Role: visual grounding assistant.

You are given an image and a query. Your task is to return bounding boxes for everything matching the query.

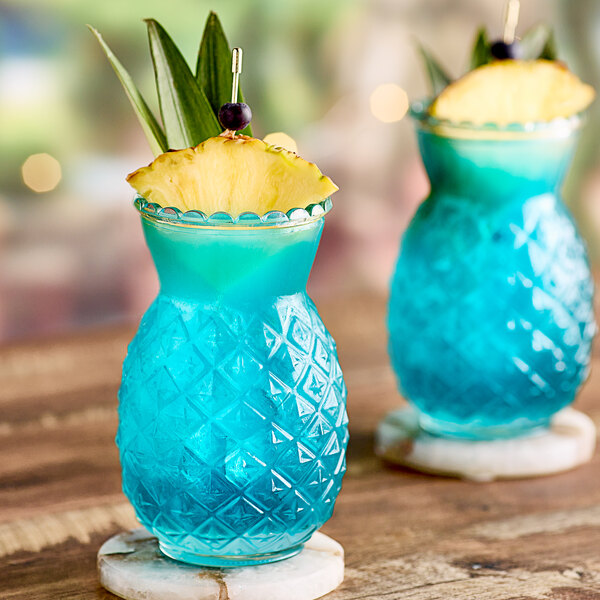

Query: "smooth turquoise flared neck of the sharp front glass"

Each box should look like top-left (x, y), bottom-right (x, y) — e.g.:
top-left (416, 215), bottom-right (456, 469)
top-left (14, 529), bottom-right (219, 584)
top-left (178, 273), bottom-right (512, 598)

top-left (142, 217), bottom-right (324, 304)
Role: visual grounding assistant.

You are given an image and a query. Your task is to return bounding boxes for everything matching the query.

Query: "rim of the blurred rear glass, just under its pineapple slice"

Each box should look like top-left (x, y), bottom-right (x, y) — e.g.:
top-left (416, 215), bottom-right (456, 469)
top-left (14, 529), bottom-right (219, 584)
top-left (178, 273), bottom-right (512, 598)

top-left (408, 98), bottom-right (586, 136)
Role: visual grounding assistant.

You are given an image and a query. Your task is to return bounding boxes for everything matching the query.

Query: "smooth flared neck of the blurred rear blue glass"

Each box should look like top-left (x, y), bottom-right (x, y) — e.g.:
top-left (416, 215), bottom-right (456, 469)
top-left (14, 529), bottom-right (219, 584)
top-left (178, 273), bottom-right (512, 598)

top-left (417, 125), bottom-right (578, 202)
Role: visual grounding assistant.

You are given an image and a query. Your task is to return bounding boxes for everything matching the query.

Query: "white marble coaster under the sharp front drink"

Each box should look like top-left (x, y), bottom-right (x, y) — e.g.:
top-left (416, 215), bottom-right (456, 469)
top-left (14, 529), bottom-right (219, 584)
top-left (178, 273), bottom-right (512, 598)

top-left (98, 528), bottom-right (344, 600)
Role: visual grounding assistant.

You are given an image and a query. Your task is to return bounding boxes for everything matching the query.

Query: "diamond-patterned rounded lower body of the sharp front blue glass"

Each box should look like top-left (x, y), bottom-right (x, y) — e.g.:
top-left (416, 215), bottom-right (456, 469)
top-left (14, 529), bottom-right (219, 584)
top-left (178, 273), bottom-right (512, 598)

top-left (118, 294), bottom-right (348, 556)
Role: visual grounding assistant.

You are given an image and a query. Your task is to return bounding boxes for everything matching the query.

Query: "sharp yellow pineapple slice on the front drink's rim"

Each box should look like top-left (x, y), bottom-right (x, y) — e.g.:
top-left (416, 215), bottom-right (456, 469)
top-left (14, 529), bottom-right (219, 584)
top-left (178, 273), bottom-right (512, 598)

top-left (127, 135), bottom-right (338, 217)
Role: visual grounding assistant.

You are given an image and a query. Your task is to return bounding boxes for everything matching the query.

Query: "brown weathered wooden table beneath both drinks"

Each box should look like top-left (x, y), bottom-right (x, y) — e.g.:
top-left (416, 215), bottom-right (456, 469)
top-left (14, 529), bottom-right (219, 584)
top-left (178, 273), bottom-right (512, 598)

top-left (0, 297), bottom-right (600, 600)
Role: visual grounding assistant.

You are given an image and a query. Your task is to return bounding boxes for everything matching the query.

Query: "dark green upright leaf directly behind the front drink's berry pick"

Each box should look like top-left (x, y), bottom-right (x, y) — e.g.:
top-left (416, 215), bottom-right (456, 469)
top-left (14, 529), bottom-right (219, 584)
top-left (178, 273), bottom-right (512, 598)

top-left (196, 12), bottom-right (252, 136)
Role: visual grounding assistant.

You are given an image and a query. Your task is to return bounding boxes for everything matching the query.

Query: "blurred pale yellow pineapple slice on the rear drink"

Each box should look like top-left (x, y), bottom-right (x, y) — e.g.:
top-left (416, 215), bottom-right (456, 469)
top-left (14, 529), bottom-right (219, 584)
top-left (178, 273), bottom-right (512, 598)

top-left (429, 60), bottom-right (595, 126)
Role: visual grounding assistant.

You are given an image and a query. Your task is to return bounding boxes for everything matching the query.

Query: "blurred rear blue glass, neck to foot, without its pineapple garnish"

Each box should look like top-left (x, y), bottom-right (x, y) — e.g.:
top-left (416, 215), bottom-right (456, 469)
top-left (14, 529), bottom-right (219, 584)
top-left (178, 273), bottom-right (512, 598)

top-left (389, 125), bottom-right (595, 438)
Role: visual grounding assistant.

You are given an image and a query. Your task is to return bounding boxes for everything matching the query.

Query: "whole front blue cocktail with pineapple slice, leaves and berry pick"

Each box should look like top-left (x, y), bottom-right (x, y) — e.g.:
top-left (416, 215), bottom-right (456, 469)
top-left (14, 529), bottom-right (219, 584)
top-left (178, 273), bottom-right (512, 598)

top-left (92, 13), bottom-right (348, 567)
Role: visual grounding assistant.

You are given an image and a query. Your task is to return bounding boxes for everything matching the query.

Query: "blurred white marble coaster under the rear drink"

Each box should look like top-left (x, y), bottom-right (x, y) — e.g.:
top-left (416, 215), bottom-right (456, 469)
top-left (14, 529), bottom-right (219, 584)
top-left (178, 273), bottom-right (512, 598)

top-left (375, 408), bottom-right (596, 481)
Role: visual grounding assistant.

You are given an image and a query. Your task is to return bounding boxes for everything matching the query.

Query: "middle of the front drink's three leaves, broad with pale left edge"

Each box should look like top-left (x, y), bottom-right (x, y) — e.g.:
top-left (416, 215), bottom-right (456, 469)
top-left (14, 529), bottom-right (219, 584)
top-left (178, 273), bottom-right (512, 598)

top-left (146, 19), bottom-right (222, 150)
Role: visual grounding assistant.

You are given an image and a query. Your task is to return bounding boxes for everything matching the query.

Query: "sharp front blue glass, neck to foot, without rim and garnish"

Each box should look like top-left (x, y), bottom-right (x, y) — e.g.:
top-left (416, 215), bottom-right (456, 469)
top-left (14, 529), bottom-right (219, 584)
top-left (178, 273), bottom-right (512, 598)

top-left (117, 217), bottom-right (348, 566)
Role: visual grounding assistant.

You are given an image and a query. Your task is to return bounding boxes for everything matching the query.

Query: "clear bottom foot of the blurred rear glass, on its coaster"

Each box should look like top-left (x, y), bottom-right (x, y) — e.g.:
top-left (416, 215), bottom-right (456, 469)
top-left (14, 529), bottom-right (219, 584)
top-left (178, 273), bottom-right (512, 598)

top-left (418, 413), bottom-right (553, 440)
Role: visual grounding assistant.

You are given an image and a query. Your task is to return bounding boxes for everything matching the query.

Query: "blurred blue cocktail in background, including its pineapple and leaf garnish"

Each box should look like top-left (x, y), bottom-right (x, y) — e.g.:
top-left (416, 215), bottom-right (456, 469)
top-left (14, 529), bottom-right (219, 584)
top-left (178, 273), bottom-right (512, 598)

top-left (388, 29), bottom-right (596, 439)
